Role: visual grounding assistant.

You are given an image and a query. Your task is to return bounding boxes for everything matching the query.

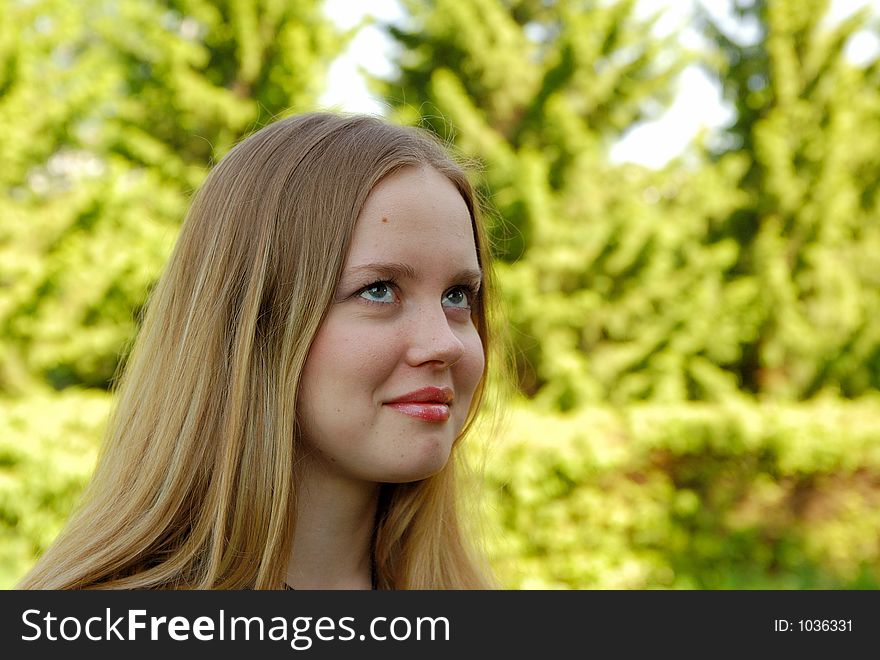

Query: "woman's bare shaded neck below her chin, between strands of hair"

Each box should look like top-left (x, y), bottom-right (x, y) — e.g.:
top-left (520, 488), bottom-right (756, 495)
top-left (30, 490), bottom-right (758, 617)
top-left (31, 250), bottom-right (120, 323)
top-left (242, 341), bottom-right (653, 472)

top-left (286, 460), bottom-right (379, 589)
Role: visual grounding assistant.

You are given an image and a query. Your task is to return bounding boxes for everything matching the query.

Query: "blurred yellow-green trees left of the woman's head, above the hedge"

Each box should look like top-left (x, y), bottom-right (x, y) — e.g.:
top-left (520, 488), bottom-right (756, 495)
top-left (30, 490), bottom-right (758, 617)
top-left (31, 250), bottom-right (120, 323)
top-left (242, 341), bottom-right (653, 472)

top-left (0, 0), bottom-right (346, 392)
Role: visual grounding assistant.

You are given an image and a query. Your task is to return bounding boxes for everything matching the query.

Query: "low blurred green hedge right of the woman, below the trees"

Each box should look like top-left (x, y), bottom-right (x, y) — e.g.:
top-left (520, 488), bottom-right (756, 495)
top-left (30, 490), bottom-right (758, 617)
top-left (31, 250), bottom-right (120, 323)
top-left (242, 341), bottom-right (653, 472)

top-left (486, 399), bottom-right (880, 589)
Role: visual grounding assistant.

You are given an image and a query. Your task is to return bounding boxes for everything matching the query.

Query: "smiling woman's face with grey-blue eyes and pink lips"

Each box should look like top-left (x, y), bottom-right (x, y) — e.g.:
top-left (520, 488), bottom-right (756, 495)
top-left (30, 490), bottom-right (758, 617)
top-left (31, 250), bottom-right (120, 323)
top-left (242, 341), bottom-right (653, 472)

top-left (299, 167), bottom-right (484, 483)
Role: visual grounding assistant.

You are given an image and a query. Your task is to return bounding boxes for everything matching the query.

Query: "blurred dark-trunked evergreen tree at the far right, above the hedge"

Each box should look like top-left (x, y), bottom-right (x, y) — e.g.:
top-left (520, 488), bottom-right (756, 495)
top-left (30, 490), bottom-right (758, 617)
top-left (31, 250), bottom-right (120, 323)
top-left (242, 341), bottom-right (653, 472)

top-left (704, 0), bottom-right (880, 399)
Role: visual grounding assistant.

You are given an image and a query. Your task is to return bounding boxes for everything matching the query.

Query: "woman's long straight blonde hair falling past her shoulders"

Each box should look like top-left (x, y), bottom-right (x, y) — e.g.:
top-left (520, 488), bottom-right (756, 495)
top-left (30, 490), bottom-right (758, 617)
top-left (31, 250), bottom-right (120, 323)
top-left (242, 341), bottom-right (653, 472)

top-left (19, 113), bottom-right (492, 589)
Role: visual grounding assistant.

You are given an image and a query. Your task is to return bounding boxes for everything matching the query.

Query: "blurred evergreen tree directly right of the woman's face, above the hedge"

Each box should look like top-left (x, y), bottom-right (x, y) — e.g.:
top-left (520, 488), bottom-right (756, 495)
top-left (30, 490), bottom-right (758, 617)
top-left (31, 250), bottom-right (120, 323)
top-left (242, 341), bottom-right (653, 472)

top-left (383, 0), bottom-right (764, 410)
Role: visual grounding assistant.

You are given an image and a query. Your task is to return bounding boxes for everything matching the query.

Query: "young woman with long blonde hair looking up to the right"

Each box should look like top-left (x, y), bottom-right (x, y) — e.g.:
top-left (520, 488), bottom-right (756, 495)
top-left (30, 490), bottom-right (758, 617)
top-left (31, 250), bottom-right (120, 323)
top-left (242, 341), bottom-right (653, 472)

top-left (19, 113), bottom-right (502, 589)
